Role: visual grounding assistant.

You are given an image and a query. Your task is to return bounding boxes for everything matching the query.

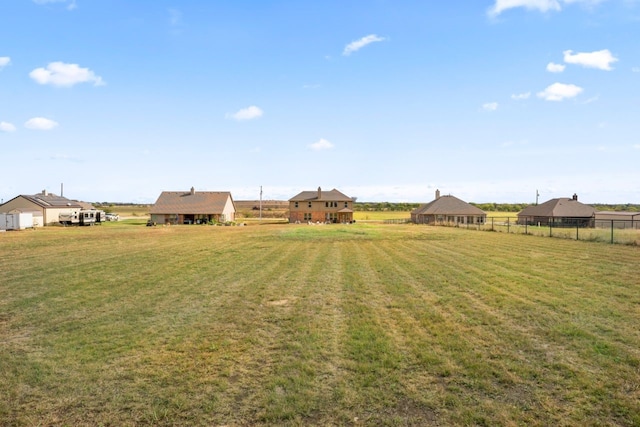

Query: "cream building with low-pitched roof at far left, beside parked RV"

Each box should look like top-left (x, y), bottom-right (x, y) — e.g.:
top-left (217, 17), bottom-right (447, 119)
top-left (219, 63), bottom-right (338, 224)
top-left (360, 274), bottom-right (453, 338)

top-left (0, 190), bottom-right (85, 227)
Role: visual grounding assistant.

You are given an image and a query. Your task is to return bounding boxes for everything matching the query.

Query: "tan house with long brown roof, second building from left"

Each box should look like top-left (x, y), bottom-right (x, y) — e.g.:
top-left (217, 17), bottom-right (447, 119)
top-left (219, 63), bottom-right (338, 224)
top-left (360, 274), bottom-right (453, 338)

top-left (149, 187), bottom-right (236, 225)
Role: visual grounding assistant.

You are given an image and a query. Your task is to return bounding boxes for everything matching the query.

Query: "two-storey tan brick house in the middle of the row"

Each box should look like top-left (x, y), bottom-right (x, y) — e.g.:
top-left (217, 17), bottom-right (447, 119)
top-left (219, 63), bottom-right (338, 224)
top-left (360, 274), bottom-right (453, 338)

top-left (289, 187), bottom-right (353, 223)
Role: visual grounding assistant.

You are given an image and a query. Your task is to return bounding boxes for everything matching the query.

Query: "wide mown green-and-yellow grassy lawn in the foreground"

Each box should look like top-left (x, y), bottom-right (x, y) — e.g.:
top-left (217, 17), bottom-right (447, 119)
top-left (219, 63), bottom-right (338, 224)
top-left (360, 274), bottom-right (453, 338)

top-left (0, 226), bottom-right (640, 426)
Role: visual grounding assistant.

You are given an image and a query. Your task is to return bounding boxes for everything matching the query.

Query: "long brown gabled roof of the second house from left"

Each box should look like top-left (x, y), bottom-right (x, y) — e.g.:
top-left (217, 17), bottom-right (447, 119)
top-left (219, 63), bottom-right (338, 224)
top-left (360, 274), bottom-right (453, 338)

top-left (149, 191), bottom-right (235, 215)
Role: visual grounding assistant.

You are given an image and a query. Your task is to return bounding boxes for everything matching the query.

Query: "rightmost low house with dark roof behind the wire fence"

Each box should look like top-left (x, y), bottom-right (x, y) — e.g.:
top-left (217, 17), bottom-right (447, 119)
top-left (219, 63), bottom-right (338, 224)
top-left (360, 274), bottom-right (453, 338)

top-left (518, 194), bottom-right (596, 227)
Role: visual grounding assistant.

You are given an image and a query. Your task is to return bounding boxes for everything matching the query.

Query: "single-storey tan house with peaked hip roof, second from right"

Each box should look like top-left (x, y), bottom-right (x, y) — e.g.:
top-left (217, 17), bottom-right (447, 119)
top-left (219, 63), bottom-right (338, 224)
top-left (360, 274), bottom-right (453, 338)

top-left (411, 190), bottom-right (487, 225)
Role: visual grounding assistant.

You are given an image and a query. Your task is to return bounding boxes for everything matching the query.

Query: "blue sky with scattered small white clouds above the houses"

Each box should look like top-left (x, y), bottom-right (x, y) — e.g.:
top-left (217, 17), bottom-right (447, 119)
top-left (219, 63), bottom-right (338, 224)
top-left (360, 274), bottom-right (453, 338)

top-left (0, 0), bottom-right (640, 203)
